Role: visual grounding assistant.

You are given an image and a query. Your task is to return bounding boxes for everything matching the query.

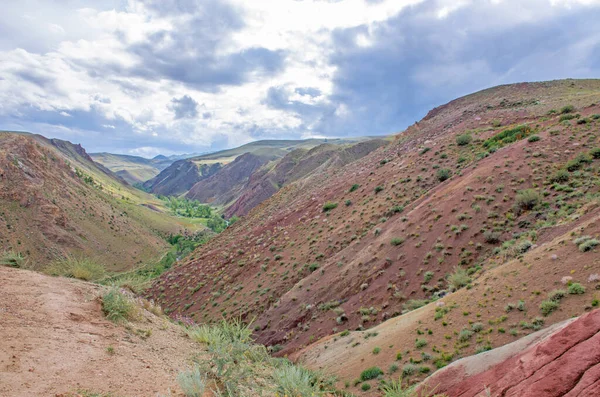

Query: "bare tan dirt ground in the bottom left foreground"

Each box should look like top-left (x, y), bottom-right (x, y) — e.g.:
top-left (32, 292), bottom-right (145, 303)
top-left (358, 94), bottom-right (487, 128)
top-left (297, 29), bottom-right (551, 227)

top-left (0, 267), bottom-right (202, 397)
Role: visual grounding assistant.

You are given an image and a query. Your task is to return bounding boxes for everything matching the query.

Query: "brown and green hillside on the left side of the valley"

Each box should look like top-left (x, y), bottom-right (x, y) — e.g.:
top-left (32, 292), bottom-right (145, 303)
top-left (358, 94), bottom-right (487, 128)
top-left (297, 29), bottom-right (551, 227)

top-left (0, 132), bottom-right (203, 271)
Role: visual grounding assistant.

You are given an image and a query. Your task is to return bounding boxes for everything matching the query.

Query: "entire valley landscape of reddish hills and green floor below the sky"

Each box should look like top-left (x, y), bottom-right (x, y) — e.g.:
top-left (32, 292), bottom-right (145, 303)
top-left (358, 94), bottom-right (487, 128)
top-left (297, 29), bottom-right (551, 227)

top-left (0, 79), bottom-right (600, 397)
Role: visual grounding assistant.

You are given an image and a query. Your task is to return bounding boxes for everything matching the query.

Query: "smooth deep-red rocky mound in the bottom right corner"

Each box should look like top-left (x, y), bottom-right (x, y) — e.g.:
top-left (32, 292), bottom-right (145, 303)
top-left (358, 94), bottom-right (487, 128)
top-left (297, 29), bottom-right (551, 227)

top-left (425, 310), bottom-right (600, 397)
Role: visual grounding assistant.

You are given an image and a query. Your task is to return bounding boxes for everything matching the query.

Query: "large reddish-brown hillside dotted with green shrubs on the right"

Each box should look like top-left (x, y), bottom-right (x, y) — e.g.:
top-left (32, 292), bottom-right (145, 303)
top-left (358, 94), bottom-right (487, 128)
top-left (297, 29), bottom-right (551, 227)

top-left (148, 80), bottom-right (600, 392)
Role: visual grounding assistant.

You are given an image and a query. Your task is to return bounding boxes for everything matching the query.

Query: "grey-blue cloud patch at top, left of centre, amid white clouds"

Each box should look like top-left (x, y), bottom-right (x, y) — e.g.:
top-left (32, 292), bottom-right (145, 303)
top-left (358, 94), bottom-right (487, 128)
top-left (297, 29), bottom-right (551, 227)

top-left (122, 0), bottom-right (285, 92)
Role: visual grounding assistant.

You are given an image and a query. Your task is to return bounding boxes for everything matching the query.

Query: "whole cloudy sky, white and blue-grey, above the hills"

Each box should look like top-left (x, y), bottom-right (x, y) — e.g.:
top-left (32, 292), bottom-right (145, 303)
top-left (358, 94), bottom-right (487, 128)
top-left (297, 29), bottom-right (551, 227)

top-left (0, 0), bottom-right (600, 156)
